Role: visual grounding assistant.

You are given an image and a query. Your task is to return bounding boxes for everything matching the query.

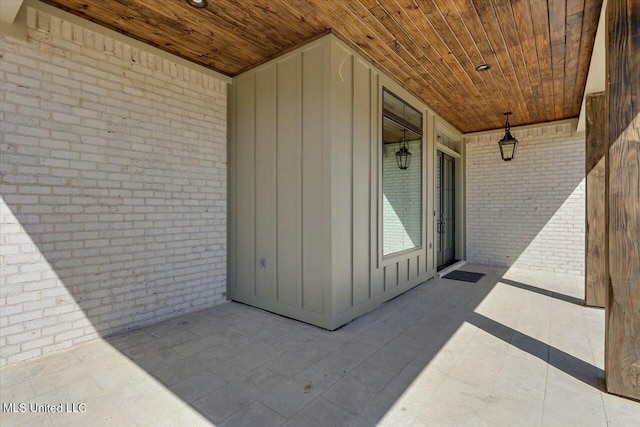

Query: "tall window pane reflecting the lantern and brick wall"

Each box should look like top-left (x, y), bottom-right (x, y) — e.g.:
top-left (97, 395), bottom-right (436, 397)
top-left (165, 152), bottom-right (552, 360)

top-left (382, 91), bottom-right (422, 255)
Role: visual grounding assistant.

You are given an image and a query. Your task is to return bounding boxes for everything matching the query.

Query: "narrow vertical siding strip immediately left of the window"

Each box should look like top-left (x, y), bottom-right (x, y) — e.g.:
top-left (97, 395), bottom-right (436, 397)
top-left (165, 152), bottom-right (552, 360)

top-left (369, 71), bottom-right (385, 298)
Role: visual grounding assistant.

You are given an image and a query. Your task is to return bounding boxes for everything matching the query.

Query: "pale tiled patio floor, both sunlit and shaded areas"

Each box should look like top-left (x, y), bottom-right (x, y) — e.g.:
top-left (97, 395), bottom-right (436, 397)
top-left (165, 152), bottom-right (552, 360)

top-left (0, 266), bottom-right (640, 427)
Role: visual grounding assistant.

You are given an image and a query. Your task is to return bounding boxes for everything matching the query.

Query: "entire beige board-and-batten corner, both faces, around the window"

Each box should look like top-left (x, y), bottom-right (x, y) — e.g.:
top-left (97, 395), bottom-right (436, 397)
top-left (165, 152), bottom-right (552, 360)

top-left (228, 35), bottom-right (435, 329)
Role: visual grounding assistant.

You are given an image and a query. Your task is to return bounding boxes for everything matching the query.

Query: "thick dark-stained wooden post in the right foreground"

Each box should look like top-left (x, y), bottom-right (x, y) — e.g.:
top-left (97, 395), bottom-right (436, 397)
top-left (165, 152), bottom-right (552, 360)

top-left (605, 0), bottom-right (640, 400)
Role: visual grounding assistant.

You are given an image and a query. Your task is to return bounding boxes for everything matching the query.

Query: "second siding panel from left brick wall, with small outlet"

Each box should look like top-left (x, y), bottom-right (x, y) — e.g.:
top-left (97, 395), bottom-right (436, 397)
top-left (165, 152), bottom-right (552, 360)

top-left (255, 65), bottom-right (277, 300)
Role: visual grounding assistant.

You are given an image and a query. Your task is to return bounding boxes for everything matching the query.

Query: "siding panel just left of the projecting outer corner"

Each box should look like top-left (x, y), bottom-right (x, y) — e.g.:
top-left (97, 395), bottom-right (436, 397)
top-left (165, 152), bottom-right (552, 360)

top-left (302, 45), bottom-right (329, 313)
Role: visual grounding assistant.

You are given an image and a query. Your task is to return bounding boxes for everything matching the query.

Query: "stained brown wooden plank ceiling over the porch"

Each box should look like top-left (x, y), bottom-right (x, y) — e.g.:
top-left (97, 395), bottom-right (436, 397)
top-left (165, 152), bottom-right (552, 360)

top-left (46, 0), bottom-right (602, 132)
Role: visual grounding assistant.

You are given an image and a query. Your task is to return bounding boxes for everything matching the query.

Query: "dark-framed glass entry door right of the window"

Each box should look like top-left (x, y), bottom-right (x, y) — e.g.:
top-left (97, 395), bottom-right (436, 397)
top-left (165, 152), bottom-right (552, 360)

top-left (436, 151), bottom-right (456, 268)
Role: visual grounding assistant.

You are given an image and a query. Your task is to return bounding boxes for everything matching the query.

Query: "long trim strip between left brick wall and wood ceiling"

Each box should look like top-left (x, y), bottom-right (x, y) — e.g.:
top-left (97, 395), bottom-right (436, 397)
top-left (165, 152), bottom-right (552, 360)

top-left (28, 0), bottom-right (231, 84)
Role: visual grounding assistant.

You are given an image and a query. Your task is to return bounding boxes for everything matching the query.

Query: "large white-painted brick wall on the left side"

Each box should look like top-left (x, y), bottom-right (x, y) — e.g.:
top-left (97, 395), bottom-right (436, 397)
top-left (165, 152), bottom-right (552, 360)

top-left (0, 9), bottom-right (226, 365)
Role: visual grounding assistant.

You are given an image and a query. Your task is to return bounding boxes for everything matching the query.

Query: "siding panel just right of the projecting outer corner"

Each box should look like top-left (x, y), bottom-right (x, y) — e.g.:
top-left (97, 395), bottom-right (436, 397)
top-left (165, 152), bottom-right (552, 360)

top-left (331, 45), bottom-right (354, 313)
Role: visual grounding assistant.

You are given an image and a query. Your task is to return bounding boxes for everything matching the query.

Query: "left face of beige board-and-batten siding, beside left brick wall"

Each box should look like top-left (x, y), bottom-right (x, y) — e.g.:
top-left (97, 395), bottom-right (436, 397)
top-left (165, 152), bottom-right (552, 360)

top-left (228, 39), bottom-right (330, 327)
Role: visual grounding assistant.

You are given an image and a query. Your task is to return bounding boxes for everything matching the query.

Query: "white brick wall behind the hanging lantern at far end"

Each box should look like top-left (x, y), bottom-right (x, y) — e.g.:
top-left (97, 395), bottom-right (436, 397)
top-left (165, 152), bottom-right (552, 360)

top-left (465, 123), bottom-right (585, 275)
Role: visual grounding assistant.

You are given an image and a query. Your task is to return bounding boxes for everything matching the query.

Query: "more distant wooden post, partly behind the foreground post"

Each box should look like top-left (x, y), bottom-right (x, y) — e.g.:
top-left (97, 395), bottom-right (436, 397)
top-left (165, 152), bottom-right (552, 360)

top-left (584, 92), bottom-right (609, 307)
